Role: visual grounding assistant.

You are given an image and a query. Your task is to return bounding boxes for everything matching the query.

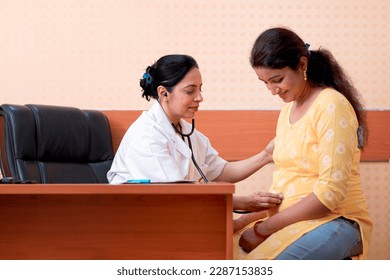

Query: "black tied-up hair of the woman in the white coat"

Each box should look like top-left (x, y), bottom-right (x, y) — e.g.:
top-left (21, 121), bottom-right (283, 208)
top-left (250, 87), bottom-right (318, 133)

top-left (139, 54), bottom-right (199, 101)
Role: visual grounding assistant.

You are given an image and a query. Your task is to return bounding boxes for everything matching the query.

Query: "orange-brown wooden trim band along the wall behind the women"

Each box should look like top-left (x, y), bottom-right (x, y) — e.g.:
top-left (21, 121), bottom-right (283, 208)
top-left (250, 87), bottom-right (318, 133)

top-left (104, 110), bottom-right (390, 162)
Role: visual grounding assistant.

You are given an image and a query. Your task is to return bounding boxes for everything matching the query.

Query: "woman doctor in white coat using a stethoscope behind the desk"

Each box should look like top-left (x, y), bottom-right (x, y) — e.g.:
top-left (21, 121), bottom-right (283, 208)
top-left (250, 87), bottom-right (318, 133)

top-left (107, 55), bottom-right (281, 211)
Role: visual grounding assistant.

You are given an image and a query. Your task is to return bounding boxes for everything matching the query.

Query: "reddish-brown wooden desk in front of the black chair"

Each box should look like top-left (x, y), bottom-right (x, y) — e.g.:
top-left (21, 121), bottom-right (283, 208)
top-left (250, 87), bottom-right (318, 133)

top-left (0, 183), bottom-right (234, 260)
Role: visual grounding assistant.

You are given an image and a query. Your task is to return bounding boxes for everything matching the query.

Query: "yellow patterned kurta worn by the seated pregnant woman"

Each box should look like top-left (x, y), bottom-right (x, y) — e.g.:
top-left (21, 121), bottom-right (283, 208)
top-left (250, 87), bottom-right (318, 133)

top-left (234, 88), bottom-right (372, 259)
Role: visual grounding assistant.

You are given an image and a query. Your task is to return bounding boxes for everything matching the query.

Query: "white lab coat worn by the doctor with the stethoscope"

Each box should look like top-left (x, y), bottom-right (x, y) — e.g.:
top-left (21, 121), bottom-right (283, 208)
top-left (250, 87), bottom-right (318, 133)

top-left (107, 101), bottom-right (227, 184)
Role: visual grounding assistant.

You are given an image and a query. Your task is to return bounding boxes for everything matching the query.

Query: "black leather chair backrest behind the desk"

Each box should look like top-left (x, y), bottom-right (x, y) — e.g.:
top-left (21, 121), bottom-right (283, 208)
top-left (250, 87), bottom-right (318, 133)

top-left (0, 104), bottom-right (114, 183)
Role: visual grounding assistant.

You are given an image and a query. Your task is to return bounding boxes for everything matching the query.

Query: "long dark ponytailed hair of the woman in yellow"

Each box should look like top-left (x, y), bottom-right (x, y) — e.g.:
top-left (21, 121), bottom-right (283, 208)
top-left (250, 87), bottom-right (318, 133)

top-left (250, 27), bottom-right (368, 149)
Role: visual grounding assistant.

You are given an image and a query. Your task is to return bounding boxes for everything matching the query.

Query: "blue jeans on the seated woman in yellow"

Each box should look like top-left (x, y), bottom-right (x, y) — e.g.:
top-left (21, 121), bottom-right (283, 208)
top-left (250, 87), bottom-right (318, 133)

top-left (275, 217), bottom-right (363, 260)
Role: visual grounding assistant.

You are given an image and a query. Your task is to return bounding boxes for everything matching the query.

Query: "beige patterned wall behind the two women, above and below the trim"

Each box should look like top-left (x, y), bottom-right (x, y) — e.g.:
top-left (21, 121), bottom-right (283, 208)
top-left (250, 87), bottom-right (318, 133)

top-left (0, 0), bottom-right (390, 259)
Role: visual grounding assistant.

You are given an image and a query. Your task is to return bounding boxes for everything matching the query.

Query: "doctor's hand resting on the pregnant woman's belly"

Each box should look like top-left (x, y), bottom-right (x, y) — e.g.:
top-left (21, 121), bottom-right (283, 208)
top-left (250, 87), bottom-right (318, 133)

top-left (233, 192), bottom-right (283, 212)
